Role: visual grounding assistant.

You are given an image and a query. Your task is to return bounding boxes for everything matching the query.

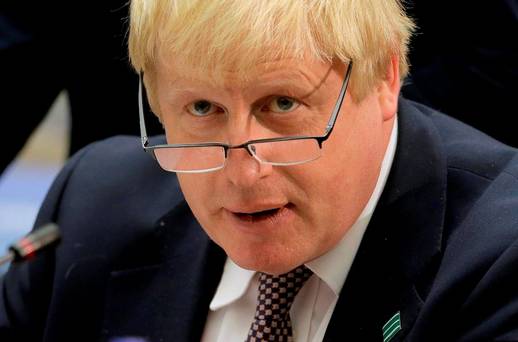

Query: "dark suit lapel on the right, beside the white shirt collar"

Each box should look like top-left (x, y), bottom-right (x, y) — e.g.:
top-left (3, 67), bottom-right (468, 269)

top-left (325, 100), bottom-right (446, 341)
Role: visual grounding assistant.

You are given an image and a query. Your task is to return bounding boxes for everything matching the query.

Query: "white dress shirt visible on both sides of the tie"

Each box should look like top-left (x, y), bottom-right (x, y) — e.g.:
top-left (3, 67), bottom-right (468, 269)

top-left (202, 116), bottom-right (397, 342)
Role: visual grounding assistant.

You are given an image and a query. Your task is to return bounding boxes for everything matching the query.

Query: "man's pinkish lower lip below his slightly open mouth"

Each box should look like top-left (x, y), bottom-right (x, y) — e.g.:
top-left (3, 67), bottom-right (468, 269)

top-left (227, 205), bottom-right (295, 233)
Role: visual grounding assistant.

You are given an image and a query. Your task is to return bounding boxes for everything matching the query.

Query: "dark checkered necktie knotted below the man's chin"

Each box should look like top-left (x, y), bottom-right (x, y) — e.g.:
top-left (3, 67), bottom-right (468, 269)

top-left (246, 265), bottom-right (312, 342)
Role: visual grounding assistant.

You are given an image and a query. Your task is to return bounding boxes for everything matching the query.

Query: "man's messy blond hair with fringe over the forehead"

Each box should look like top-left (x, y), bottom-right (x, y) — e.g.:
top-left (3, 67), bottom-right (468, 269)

top-left (129, 0), bottom-right (414, 100)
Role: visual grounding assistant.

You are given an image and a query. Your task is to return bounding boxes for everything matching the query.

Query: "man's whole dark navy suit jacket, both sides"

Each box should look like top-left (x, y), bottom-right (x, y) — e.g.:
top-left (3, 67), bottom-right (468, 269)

top-left (0, 99), bottom-right (518, 342)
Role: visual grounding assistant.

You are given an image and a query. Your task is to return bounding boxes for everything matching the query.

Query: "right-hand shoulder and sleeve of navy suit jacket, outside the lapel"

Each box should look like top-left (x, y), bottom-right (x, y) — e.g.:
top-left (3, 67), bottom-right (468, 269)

top-left (402, 101), bottom-right (518, 340)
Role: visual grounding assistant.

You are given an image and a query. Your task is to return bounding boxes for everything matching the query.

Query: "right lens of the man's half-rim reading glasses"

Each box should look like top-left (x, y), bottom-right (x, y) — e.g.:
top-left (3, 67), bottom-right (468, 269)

top-left (250, 138), bottom-right (322, 165)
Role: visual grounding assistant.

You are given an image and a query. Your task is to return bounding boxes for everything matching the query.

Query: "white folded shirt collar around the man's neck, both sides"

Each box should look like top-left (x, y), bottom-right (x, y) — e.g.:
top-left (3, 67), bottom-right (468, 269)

top-left (210, 115), bottom-right (398, 311)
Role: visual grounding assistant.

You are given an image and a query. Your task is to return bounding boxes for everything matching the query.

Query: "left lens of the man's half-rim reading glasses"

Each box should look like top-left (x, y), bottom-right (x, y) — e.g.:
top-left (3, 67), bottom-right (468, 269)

top-left (153, 146), bottom-right (225, 172)
